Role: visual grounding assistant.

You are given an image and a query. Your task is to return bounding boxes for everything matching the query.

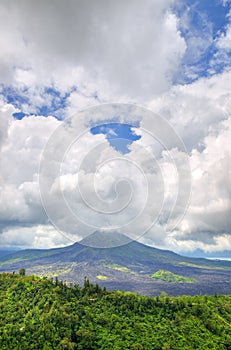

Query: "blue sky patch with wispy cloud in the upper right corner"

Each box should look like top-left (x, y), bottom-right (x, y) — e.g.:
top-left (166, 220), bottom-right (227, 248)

top-left (175, 0), bottom-right (230, 83)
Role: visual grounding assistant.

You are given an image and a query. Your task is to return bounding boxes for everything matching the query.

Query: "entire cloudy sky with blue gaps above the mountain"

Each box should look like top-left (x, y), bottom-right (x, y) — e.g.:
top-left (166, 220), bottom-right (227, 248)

top-left (0, 0), bottom-right (231, 257)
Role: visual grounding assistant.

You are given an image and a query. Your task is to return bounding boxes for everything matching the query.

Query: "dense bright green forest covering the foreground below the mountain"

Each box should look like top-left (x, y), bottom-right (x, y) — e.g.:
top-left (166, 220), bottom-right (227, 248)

top-left (0, 271), bottom-right (231, 350)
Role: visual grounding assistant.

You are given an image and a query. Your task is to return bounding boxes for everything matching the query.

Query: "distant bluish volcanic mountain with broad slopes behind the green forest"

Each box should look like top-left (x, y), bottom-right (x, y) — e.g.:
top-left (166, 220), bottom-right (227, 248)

top-left (0, 232), bottom-right (231, 295)
